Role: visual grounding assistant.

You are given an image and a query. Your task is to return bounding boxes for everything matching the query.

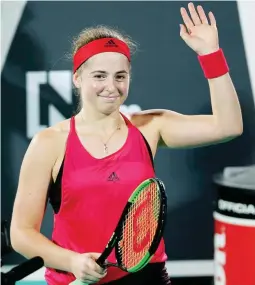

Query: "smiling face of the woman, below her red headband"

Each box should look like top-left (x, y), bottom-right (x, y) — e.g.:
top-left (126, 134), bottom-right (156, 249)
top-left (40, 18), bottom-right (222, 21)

top-left (73, 52), bottom-right (130, 115)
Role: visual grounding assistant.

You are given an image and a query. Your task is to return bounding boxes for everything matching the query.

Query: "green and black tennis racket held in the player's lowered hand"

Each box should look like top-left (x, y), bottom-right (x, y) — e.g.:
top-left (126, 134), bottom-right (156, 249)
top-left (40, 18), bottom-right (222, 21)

top-left (70, 178), bottom-right (167, 285)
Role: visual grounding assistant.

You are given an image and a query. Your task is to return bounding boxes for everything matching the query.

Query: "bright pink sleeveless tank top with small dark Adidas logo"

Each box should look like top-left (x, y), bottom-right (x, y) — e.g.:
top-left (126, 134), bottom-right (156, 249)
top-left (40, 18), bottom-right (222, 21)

top-left (45, 116), bottom-right (167, 285)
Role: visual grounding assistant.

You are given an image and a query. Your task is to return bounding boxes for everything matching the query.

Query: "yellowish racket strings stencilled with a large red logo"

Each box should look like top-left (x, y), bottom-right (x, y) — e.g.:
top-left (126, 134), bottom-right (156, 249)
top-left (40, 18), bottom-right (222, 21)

top-left (119, 183), bottom-right (160, 268)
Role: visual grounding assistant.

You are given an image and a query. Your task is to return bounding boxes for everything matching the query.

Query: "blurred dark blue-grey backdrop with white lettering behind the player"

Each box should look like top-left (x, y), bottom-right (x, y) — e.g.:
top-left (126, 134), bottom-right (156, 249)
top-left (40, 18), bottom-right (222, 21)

top-left (1, 1), bottom-right (255, 285)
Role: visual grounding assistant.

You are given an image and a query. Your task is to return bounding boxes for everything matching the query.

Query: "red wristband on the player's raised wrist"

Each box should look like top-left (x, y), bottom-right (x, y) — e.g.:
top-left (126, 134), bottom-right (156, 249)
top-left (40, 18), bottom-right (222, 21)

top-left (198, 49), bottom-right (229, 79)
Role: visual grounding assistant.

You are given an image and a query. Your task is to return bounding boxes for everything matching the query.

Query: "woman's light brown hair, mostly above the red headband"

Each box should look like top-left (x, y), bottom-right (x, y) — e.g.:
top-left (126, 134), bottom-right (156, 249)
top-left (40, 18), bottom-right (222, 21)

top-left (72, 25), bottom-right (137, 110)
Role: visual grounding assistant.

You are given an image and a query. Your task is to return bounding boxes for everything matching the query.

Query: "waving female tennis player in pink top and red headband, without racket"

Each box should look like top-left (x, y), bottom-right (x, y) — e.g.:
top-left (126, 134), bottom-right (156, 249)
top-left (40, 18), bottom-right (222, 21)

top-left (11, 3), bottom-right (243, 285)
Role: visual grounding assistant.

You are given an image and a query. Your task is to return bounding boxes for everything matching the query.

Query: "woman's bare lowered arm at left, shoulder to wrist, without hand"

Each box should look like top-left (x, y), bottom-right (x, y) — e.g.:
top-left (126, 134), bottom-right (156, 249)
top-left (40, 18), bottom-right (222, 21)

top-left (11, 129), bottom-right (75, 271)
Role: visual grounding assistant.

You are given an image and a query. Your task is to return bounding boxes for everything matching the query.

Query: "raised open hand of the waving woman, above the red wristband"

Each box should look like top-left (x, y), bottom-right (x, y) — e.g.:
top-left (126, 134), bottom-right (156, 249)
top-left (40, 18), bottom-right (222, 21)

top-left (180, 3), bottom-right (219, 55)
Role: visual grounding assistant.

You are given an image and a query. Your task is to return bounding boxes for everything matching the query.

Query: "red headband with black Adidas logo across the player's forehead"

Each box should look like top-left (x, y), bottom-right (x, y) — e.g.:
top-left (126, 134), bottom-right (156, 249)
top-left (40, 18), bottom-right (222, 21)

top-left (73, 38), bottom-right (130, 73)
